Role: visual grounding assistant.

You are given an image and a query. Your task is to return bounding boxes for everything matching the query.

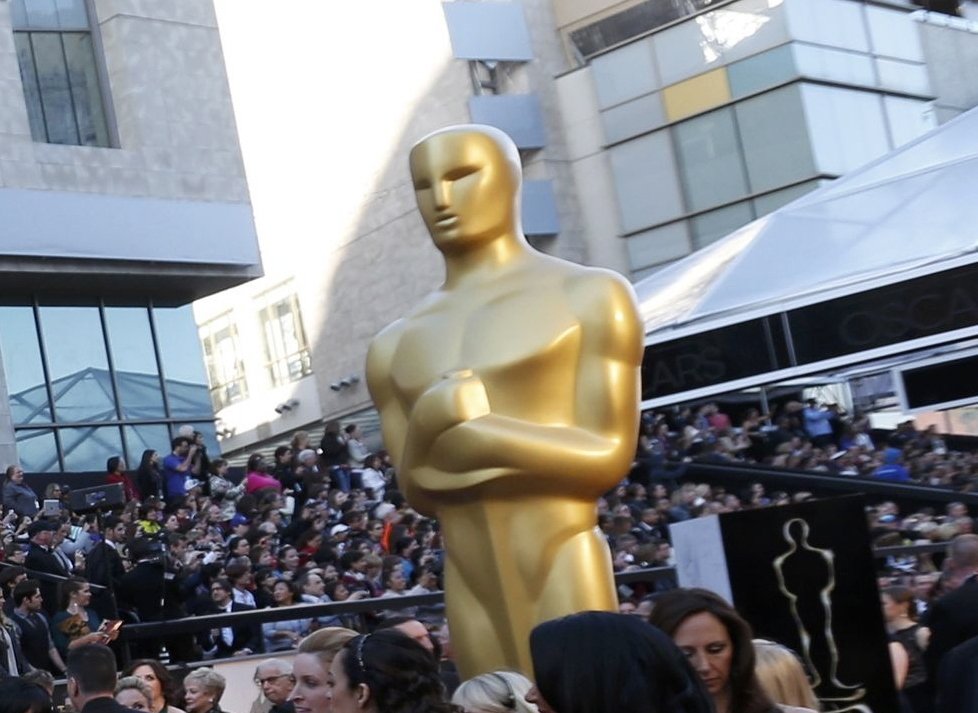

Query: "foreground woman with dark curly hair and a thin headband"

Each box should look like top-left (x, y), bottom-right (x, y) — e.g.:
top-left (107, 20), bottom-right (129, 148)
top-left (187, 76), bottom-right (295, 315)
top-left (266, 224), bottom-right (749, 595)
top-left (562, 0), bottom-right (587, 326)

top-left (327, 629), bottom-right (455, 713)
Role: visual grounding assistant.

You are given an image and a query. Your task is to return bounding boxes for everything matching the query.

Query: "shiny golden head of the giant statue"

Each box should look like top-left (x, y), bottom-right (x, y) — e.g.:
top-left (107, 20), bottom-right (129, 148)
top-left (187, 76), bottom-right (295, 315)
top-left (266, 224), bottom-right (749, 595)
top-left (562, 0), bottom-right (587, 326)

top-left (410, 131), bottom-right (519, 251)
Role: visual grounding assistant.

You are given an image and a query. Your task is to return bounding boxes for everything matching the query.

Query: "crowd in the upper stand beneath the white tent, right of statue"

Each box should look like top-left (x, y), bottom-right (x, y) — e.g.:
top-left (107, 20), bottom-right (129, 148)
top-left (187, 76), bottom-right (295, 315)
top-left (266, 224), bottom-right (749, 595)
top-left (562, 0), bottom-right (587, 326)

top-left (638, 399), bottom-right (978, 491)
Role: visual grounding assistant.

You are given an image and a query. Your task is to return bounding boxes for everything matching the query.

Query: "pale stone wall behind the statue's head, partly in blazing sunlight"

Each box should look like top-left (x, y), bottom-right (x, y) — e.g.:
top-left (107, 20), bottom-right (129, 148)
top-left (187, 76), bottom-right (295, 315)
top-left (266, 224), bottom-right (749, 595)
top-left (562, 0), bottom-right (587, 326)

top-left (195, 0), bottom-right (587, 452)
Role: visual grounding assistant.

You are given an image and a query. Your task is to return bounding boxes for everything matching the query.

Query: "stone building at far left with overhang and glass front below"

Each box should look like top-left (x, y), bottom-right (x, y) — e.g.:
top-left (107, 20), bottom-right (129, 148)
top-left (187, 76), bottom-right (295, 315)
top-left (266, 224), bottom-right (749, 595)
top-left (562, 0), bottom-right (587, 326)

top-left (0, 0), bottom-right (261, 472)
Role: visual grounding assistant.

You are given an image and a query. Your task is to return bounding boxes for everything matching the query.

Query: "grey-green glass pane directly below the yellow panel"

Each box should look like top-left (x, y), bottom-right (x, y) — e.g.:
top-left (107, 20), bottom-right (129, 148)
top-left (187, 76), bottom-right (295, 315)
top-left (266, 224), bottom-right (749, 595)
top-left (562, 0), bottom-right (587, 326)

top-left (675, 109), bottom-right (747, 211)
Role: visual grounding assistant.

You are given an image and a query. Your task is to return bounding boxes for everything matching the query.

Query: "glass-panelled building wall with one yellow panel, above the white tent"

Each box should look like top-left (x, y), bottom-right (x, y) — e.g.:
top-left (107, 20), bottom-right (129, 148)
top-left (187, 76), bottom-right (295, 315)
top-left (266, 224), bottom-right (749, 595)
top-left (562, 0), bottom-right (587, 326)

top-left (557, 0), bottom-right (937, 279)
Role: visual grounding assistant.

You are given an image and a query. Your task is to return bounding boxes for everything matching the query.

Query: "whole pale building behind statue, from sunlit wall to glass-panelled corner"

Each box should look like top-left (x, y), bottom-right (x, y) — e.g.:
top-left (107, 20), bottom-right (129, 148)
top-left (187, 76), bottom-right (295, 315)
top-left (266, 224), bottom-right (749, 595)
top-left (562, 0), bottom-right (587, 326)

top-left (195, 0), bottom-right (978, 457)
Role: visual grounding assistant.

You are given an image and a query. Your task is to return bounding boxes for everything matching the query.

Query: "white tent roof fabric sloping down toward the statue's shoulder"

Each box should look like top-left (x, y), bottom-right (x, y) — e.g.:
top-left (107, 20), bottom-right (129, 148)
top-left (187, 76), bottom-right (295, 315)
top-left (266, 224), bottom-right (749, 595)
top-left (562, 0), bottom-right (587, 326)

top-left (635, 109), bottom-right (978, 341)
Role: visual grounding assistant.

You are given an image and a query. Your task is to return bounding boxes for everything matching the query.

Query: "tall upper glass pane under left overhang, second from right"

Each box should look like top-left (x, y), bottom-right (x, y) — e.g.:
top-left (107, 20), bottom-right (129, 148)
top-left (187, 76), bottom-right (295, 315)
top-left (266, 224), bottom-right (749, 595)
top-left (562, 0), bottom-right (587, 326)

top-left (105, 307), bottom-right (166, 419)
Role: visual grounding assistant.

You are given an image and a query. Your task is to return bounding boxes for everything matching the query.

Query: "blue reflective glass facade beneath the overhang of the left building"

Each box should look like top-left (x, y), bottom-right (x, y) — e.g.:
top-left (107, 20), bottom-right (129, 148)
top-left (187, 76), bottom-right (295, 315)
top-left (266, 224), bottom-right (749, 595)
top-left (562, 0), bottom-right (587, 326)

top-left (0, 300), bottom-right (219, 472)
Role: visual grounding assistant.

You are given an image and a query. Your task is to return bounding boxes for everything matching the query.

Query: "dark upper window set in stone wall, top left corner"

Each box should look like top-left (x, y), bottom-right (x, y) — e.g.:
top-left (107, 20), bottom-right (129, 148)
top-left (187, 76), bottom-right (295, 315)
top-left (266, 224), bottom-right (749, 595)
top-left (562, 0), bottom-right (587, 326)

top-left (10, 0), bottom-right (110, 146)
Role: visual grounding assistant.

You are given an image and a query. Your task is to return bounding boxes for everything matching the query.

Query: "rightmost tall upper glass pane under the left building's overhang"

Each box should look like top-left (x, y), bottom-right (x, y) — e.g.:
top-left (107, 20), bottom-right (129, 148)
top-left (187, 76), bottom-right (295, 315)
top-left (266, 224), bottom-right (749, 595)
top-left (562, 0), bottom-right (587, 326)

top-left (153, 305), bottom-right (214, 419)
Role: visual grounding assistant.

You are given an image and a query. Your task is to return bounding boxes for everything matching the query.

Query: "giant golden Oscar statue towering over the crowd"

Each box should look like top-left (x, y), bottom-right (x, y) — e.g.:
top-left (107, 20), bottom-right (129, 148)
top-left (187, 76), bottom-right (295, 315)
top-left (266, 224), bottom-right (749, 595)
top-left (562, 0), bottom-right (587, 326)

top-left (367, 126), bottom-right (642, 677)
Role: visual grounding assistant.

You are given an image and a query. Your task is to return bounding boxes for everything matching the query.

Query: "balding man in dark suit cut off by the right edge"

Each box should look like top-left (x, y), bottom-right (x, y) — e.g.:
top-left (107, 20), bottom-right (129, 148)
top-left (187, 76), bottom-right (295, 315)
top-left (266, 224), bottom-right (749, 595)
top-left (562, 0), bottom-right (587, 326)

top-left (922, 535), bottom-right (978, 681)
